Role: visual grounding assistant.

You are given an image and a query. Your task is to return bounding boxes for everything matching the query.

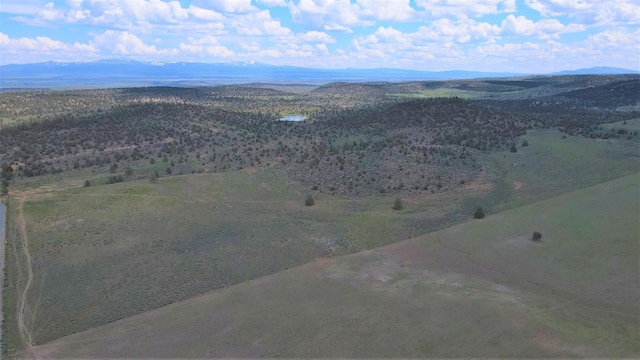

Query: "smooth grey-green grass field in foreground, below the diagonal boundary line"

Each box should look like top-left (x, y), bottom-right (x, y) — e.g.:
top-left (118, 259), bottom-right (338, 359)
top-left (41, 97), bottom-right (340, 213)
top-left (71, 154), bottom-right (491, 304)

top-left (35, 174), bottom-right (640, 358)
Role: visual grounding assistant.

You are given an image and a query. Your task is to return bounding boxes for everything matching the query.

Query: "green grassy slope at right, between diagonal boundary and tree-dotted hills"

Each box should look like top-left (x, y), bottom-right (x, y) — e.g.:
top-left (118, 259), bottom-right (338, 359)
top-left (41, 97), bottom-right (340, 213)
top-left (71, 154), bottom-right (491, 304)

top-left (487, 128), bottom-right (640, 207)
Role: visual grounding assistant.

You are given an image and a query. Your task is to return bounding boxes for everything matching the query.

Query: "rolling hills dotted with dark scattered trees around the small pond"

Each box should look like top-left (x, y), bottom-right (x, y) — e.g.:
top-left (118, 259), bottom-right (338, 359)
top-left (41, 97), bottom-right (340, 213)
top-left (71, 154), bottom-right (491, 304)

top-left (0, 75), bottom-right (640, 196)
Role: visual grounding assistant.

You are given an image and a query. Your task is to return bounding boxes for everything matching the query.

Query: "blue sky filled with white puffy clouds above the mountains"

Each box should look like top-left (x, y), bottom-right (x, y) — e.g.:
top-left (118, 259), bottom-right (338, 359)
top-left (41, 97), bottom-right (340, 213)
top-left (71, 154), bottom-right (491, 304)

top-left (0, 0), bottom-right (640, 73)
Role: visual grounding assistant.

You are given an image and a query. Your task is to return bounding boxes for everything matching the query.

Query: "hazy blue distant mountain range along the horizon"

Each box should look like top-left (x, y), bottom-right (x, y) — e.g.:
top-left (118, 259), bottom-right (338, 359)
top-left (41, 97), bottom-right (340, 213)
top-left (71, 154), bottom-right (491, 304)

top-left (0, 59), bottom-right (640, 89)
